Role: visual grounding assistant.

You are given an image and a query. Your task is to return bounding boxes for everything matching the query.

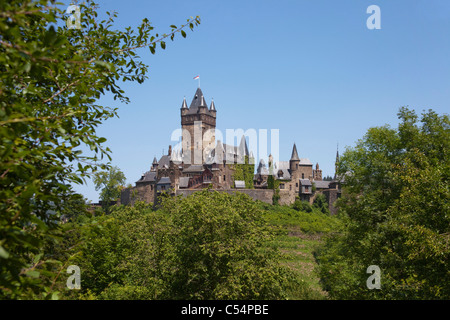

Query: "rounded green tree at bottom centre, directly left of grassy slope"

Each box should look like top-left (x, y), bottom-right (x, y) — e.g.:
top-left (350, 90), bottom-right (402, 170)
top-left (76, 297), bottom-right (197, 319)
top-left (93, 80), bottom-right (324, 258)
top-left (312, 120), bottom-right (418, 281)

top-left (162, 190), bottom-right (288, 299)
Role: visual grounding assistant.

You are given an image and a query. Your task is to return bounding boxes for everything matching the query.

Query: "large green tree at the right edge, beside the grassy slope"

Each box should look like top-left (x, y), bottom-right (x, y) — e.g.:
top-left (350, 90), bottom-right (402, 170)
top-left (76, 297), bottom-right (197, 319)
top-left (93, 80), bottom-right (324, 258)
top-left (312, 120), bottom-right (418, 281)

top-left (319, 107), bottom-right (450, 299)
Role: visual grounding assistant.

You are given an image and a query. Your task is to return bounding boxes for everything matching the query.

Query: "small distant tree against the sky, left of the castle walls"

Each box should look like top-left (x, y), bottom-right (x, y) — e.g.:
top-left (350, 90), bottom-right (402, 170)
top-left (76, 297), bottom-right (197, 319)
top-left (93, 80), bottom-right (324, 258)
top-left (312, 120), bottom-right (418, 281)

top-left (93, 167), bottom-right (126, 214)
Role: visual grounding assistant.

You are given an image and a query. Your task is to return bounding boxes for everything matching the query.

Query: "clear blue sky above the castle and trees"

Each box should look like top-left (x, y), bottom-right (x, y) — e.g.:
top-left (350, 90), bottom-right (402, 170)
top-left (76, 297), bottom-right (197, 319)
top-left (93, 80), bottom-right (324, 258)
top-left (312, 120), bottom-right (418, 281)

top-left (68, 0), bottom-right (450, 202)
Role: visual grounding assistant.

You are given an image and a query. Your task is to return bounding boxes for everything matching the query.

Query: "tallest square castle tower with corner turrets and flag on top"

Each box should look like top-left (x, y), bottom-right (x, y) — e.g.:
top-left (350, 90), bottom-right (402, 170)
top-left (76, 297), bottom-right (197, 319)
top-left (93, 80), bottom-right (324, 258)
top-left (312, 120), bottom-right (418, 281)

top-left (181, 88), bottom-right (217, 165)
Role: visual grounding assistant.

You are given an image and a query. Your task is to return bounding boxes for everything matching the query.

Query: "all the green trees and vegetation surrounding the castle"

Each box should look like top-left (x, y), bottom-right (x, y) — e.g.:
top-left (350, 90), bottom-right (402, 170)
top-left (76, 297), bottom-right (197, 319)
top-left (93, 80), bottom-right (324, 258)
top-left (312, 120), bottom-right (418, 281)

top-left (0, 0), bottom-right (450, 299)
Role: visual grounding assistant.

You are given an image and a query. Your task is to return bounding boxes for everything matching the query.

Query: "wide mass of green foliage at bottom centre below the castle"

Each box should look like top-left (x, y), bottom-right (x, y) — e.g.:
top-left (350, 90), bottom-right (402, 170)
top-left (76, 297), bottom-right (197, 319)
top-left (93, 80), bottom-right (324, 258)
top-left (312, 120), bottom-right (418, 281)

top-left (61, 190), bottom-right (290, 299)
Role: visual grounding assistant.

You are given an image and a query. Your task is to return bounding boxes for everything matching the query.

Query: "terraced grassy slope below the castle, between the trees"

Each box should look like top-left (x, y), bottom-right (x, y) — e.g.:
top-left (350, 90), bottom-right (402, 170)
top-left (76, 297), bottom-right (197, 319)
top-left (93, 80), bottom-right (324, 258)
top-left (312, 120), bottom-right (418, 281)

top-left (262, 204), bottom-right (339, 300)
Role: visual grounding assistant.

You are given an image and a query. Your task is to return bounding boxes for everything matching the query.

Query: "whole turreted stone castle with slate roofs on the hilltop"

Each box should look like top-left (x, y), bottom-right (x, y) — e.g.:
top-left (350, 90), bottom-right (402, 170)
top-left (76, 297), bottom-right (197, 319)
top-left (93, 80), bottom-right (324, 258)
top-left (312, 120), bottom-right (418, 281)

top-left (120, 88), bottom-right (341, 214)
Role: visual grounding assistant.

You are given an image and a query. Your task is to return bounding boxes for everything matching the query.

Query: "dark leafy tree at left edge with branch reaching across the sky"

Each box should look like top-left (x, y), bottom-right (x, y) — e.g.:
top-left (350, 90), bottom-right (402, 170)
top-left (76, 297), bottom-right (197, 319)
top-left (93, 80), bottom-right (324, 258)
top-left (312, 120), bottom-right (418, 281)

top-left (0, 0), bottom-right (199, 298)
